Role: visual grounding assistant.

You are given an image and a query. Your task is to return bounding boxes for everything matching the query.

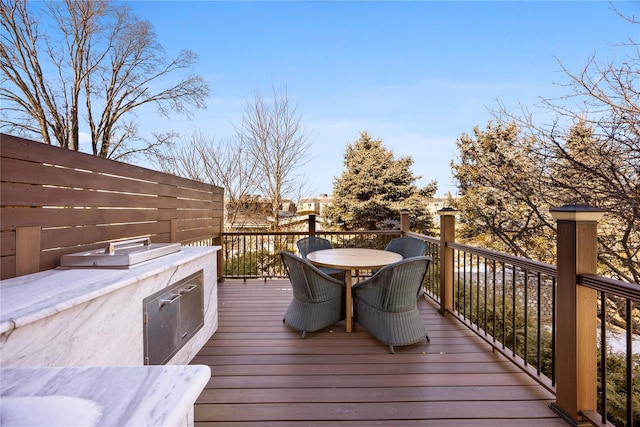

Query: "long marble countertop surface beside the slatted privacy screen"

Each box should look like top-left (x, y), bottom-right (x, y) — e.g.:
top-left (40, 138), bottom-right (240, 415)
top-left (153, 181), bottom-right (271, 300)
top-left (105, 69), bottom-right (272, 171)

top-left (0, 246), bottom-right (220, 334)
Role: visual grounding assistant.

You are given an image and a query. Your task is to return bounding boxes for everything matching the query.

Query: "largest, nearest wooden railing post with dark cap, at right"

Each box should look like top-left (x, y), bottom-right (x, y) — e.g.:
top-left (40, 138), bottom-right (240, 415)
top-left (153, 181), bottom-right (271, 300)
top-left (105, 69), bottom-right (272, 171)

top-left (550, 205), bottom-right (604, 426)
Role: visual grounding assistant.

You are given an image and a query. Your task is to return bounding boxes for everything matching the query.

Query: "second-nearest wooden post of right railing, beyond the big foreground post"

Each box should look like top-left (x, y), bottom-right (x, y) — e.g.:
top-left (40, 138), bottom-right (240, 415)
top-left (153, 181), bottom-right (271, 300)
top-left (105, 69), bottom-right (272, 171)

top-left (438, 208), bottom-right (458, 316)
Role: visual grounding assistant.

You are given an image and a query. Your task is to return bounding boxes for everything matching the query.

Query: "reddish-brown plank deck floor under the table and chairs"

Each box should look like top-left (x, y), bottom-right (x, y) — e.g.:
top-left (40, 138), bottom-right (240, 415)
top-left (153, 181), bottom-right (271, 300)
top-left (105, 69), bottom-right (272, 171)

top-left (192, 280), bottom-right (567, 427)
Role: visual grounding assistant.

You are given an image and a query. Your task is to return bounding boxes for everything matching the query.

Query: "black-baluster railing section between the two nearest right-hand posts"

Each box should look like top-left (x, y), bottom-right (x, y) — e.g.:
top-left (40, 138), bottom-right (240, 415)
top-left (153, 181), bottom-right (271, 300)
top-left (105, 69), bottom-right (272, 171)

top-left (446, 242), bottom-right (556, 391)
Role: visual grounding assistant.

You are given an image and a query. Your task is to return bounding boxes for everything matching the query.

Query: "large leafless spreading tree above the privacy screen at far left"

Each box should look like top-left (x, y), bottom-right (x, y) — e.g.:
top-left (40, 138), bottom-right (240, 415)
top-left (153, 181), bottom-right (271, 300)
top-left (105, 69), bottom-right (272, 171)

top-left (0, 0), bottom-right (209, 159)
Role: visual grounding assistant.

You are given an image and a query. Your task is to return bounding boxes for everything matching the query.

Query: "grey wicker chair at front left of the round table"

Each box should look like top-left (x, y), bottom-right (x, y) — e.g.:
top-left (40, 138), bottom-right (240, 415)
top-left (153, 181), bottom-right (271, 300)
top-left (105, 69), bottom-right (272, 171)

top-left (280, 251), bottom-right (345, 338)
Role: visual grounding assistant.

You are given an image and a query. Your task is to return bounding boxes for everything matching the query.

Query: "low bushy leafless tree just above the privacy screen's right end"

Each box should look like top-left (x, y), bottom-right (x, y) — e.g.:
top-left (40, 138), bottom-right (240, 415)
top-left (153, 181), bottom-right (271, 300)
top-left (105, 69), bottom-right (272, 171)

top-left (150, 130), bottom-right (257, 224)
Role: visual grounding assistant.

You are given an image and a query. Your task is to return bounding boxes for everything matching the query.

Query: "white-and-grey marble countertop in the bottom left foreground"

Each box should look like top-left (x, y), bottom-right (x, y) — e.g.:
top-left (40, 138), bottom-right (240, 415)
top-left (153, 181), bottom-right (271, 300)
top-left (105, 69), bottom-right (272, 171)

top-left (0, 365), bottom-right (211, 427)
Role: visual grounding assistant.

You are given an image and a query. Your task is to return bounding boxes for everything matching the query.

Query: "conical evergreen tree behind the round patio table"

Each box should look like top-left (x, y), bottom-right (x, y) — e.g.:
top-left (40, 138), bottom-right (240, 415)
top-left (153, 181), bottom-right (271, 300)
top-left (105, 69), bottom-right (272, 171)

top-left (324, 132), bottom-right (437, 233)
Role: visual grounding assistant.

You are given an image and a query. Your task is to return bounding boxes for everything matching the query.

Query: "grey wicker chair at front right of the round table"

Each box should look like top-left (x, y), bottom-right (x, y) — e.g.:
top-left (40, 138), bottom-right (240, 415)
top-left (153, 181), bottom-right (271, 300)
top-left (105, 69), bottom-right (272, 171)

top-left (352, 256), bottom-right (431, 353)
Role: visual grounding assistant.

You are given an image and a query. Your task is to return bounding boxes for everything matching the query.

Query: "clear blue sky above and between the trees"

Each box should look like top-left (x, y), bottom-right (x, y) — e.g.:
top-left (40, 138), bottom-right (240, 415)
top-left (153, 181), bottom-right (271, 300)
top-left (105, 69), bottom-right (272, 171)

top-left (124, 1), bottom-right (640, 195)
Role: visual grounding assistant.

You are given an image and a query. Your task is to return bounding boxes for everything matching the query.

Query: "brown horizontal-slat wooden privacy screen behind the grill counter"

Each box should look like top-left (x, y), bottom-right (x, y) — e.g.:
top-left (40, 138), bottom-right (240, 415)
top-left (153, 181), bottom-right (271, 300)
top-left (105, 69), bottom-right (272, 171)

top-left (0, 134), bottom-right (224, 279)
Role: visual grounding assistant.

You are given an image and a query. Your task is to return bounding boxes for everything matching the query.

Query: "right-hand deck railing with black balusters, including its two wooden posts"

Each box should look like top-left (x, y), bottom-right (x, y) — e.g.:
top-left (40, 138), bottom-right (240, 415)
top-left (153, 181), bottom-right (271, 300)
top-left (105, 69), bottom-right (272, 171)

top-left (426, 206), bottom-right (640, 426)
